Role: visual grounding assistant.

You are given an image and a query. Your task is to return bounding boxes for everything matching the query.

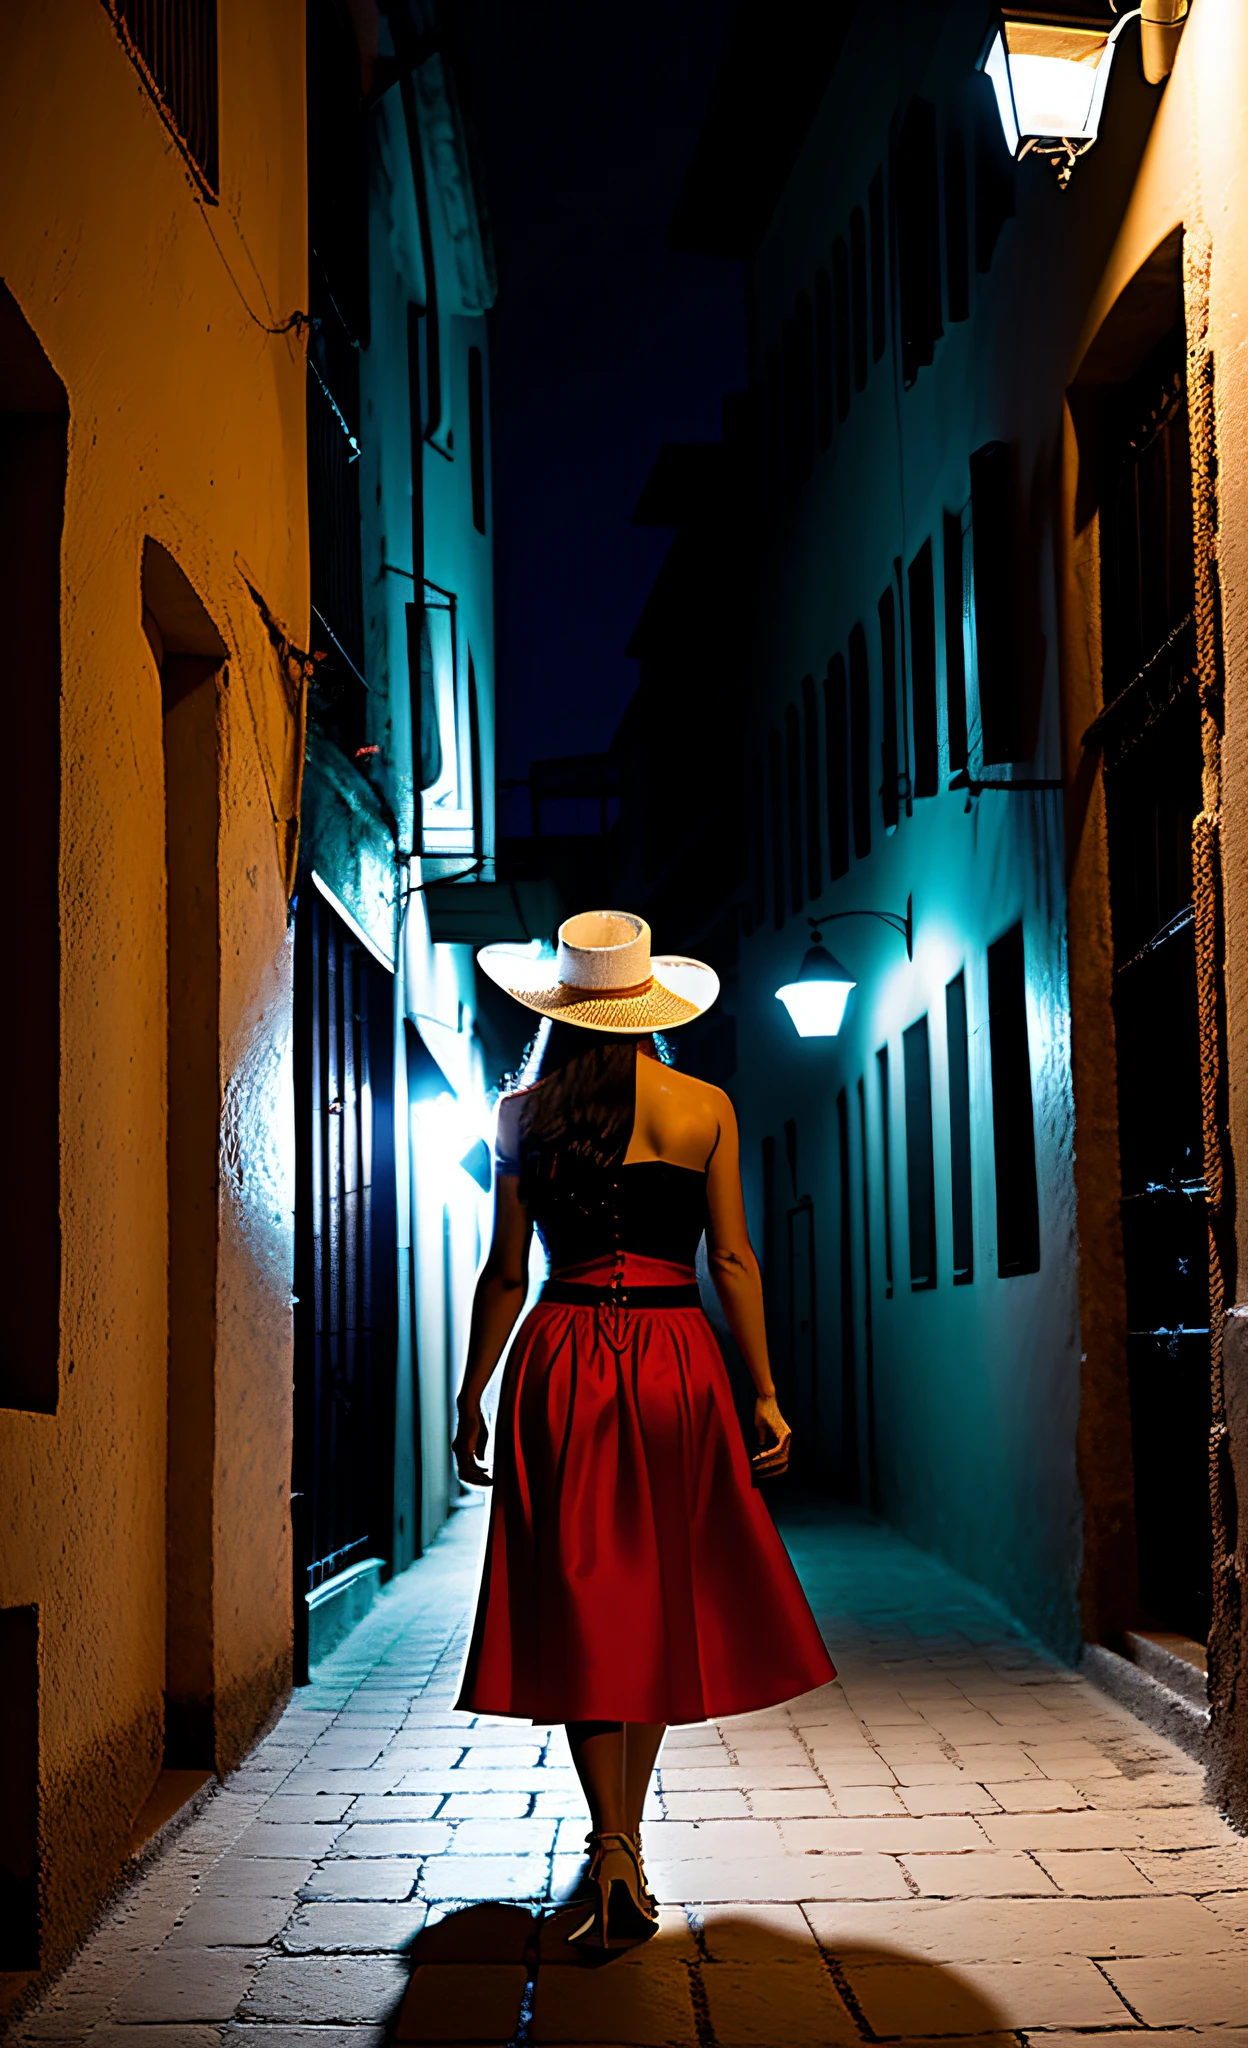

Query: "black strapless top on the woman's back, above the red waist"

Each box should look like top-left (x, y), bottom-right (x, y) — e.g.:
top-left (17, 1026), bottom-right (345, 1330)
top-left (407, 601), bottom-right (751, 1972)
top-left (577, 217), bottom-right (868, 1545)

top-left (529, 1157), bottom-right (707, 1272)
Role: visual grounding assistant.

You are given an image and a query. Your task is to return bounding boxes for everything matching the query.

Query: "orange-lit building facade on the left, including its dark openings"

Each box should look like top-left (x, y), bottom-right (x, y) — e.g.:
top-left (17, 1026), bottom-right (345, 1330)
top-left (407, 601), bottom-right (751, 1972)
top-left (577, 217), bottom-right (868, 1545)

top-left (0, 0), bottom-right (307, 1997)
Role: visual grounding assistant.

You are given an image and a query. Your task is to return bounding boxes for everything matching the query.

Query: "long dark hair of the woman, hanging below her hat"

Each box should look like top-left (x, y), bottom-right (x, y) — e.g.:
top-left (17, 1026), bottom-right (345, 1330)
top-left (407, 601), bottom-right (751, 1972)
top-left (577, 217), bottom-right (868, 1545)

top-left (521, 1024), bottom-right (672, 1200)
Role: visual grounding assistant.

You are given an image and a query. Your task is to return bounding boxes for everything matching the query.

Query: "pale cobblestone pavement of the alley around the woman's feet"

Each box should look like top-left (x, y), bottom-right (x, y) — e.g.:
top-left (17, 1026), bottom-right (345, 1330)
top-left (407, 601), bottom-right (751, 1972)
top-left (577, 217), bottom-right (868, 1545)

top-left (16, 1511), bottom-right (1248, 2048)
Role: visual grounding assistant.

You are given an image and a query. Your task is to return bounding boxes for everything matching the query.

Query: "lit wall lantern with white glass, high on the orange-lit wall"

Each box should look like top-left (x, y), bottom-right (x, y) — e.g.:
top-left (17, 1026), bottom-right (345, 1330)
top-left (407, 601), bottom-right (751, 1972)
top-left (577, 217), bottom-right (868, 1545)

top-left (980, 0), bottom-right (1189, 188)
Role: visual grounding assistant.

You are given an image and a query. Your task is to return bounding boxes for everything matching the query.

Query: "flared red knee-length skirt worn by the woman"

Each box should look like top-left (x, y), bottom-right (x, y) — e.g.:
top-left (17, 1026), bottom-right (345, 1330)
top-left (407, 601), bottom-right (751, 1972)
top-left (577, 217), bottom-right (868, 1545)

top-left (459, 1257), bottom-right (836, 1722)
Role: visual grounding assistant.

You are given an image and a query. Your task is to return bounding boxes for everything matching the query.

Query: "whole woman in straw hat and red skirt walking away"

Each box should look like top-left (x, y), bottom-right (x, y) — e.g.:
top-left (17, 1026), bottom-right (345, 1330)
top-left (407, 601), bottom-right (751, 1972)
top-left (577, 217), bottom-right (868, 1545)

top-left (455, 911), bottom-right (836, 1948)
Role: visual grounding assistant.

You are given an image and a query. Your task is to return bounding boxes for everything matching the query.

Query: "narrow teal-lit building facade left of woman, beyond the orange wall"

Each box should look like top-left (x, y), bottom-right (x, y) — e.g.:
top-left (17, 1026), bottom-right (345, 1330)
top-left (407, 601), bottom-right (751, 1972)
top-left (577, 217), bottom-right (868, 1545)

top-left (295, 0), bottom-right (502, 1671)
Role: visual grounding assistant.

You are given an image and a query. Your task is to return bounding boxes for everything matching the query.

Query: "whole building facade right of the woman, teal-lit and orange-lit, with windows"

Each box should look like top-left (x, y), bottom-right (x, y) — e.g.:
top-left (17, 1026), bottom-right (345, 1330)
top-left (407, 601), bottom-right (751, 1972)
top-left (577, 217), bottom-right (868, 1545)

top-left (651, 0), bottom-right (1248, 1815)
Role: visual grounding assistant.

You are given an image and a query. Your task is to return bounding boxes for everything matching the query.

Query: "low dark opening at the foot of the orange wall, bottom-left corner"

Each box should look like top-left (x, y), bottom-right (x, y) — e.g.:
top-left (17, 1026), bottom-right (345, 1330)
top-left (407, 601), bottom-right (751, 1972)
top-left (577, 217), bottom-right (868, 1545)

top-left (0, 1608), bottom-right (39, 1970)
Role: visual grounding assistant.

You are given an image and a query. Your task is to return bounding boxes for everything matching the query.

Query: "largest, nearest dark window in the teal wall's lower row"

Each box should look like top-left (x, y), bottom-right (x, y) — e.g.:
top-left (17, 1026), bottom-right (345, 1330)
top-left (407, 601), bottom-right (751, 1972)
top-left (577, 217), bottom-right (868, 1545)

top-left (988, 924), bottom-right (1039, 1280)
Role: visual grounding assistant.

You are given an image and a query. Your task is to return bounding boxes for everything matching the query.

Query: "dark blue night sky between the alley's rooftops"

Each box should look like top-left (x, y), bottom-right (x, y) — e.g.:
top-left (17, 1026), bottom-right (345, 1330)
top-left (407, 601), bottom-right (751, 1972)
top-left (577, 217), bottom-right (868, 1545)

top-left (465, 0), bottom-right (744, 829)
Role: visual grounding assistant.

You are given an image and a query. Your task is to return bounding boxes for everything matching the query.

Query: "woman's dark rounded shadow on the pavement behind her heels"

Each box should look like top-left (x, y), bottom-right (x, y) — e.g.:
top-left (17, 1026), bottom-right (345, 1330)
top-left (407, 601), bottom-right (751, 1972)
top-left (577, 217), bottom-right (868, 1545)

top-left (389, 1903), bottom-right (1018, 2048)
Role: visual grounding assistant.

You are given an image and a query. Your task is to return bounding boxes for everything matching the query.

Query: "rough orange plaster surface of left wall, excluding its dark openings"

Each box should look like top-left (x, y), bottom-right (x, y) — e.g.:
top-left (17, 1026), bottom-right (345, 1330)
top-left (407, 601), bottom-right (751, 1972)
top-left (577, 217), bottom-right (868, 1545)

top-left (0, 0), bottom-right (307, 1962)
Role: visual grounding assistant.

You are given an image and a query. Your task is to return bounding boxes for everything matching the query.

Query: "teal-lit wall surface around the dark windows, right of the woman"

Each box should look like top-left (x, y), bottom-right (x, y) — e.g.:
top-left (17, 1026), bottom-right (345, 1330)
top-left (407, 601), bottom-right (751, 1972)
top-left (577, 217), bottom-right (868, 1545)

top-left (734, 4), bottom-right (1158, 1655)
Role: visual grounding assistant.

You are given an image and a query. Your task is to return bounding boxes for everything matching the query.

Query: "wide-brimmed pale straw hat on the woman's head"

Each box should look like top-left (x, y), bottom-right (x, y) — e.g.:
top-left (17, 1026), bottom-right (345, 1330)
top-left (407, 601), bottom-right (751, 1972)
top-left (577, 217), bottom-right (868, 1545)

top-left (477, 909), bottom-right (719, 1032)
